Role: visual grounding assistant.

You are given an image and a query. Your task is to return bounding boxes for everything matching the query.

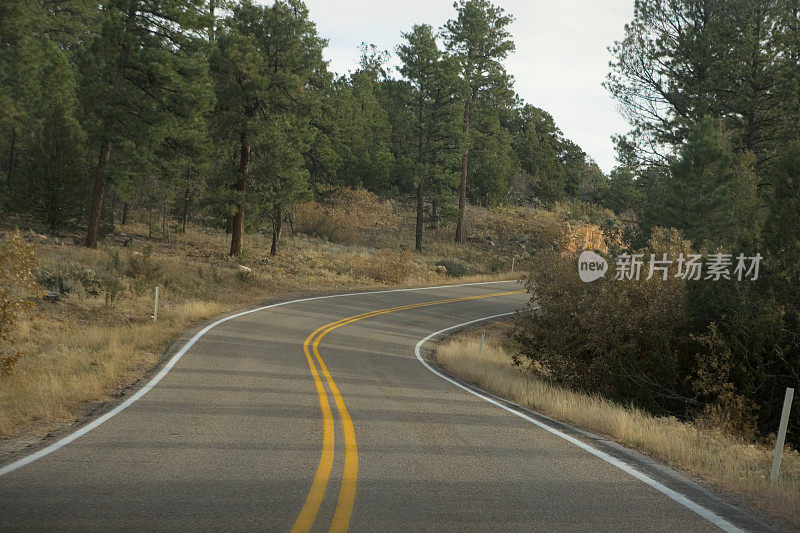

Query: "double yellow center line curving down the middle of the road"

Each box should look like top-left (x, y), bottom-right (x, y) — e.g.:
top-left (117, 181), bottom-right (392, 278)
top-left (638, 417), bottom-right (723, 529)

top-left (292, 291), bottom-right (525, 533)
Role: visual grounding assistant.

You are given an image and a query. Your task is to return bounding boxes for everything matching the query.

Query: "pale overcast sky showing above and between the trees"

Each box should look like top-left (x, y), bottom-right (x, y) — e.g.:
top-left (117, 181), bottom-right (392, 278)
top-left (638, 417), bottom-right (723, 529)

top-left (306, 0), bottom-right (633, 172)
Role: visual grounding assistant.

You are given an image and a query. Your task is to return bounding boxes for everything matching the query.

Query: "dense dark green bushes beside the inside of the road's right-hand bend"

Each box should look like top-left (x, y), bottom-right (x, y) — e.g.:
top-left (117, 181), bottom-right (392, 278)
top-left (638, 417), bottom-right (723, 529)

top-left (514, 228), bottom-right (777, 438)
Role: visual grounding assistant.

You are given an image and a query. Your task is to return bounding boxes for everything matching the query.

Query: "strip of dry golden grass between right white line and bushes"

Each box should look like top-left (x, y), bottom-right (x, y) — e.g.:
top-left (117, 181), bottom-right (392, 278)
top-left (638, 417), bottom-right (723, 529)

top-left (437, 325), bottom-right (800, 527)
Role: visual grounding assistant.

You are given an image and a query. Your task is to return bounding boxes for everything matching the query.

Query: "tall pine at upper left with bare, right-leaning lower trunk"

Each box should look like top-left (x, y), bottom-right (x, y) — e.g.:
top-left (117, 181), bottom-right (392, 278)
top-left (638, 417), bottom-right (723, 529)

top-left (80, 0), bottom-right (210, 247)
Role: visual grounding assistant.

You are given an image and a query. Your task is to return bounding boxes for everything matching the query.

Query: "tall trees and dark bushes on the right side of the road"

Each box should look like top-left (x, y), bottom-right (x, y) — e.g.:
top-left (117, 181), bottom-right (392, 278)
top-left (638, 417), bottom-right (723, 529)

top-left (519, 0), bottom-right (800, 445)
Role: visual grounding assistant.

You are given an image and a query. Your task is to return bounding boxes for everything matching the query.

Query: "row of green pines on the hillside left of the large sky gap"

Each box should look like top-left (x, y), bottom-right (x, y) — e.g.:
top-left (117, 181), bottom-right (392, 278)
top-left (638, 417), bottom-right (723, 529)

top-left (0, 0), bottom-right (608, 255)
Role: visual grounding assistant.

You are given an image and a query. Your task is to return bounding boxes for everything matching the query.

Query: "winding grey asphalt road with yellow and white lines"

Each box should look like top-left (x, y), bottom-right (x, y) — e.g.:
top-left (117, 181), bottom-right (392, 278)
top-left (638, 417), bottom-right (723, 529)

top-left (0, 282), bottom-right (768, 531)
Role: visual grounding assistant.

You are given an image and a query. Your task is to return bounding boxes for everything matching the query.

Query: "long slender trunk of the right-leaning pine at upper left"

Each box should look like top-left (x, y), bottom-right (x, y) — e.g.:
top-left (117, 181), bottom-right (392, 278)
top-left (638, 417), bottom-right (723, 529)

top-left (86, 0), bottom-right (138, 248)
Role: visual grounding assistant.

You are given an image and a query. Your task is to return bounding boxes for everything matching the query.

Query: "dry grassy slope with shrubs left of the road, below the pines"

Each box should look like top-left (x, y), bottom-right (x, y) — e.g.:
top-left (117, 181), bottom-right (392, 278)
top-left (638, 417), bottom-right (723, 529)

top-left (0, 219), bottom-right (520, 456)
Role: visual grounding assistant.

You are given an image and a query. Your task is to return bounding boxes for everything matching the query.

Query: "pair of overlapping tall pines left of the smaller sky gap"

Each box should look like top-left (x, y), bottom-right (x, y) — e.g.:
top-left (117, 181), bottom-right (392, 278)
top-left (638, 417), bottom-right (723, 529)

top-left (211, 0), bottom-right (329, 255)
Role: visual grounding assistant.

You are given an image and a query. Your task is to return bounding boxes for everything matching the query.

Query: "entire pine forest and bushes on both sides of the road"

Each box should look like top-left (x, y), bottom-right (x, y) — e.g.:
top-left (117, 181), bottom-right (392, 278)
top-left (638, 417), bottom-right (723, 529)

top-left (0, 0), bottom-right (800, 454)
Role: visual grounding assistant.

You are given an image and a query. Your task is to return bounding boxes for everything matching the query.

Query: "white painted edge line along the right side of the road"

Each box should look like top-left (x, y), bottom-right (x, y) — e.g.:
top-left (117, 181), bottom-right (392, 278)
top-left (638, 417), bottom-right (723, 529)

top-left (414, 312), bottom-right (743, 533)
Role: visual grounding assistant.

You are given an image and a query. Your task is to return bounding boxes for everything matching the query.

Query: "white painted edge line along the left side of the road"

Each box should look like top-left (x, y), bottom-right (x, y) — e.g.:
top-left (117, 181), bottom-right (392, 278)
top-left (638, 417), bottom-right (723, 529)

top-left (0, 280), bottom-right (517, 476)
